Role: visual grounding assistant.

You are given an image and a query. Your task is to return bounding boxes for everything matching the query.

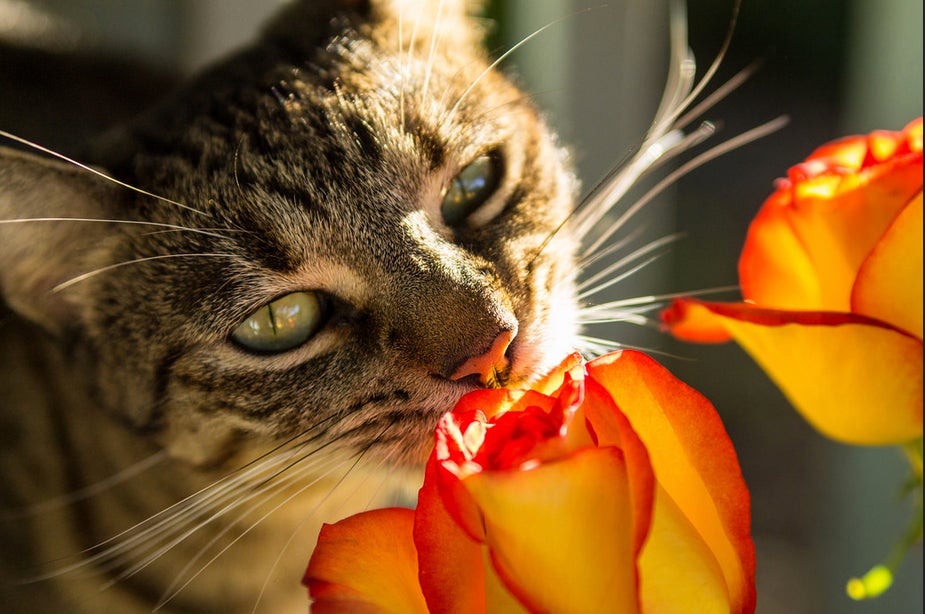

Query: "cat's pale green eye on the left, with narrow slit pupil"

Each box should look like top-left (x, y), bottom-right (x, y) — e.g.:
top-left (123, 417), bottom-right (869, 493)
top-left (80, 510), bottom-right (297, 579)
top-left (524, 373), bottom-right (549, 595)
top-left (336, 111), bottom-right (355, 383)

top-left (231, 292), bottom-right (323, 354)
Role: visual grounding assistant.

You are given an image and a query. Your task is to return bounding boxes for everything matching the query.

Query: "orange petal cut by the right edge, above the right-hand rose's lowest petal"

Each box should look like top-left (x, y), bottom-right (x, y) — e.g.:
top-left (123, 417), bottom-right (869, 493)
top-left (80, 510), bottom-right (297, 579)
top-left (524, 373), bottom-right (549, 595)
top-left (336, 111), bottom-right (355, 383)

top-left (851, 192), bottom-right (922, 339)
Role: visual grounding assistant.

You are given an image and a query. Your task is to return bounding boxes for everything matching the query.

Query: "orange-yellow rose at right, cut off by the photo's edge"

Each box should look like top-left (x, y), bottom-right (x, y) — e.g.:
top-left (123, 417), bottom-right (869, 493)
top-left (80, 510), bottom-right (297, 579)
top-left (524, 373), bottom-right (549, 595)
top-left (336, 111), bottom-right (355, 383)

top-left (663, 118), bottom-right (922, 445)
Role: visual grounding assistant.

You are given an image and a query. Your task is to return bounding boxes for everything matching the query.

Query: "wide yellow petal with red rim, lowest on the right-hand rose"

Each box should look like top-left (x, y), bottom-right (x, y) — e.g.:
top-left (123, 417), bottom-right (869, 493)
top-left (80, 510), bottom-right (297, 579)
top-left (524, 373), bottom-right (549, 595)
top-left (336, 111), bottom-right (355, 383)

top-left (672, 301), bottom-right (922, 450)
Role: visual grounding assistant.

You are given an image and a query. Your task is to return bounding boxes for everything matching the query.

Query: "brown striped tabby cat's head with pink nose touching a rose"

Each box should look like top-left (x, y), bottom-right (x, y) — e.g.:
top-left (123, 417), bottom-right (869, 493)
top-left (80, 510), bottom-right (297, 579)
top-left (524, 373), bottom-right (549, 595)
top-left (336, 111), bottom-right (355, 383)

top-left (0, 0), bottom-right (576, 470)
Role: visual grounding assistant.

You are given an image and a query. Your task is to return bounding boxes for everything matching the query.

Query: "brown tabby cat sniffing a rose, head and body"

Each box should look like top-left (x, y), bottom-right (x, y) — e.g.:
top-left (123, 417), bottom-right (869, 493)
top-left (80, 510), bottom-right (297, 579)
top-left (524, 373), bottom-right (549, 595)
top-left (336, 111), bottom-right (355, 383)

top-left (0, 0), bottom-right (756, 613)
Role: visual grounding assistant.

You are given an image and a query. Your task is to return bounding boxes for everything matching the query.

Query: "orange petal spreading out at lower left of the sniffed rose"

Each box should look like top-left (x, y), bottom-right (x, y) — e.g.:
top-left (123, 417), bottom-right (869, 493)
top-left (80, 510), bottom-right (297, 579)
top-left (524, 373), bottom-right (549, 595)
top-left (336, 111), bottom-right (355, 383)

top-left (302, 508), bottom-right (427, 614)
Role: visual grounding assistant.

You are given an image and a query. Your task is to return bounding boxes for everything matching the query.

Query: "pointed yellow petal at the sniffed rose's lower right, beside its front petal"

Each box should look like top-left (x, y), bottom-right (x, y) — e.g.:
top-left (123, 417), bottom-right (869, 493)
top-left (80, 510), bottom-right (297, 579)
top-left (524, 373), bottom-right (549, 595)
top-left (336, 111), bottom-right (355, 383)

top-left (639, 488), bottom-right (730, 614)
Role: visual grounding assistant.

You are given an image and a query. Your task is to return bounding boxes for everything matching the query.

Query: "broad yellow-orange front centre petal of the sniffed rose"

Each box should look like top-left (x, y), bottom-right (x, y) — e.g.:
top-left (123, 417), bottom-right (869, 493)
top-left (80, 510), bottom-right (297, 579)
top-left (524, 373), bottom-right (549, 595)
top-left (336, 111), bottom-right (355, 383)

top-left (464, 448), bottom-right (638, 612)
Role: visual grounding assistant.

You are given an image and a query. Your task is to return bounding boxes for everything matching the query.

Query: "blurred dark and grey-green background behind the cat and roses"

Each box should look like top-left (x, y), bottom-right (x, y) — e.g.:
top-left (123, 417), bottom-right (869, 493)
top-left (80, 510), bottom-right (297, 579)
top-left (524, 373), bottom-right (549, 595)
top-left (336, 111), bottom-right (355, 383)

top-left (0, 0), bottom-right (923, 614)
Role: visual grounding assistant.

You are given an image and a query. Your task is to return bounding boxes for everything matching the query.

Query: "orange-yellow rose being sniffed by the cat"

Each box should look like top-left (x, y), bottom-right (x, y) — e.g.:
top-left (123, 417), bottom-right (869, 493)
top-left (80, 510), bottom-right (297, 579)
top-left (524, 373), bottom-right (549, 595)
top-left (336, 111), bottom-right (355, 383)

top-left (305, 351), bottom-right (755, 613)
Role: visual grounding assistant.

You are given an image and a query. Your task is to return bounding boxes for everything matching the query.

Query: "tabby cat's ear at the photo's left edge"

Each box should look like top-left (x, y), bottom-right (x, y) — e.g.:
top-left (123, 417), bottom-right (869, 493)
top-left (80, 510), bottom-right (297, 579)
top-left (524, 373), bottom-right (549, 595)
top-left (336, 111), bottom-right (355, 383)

top-left (0, 147), bottom-right (120, 333)
